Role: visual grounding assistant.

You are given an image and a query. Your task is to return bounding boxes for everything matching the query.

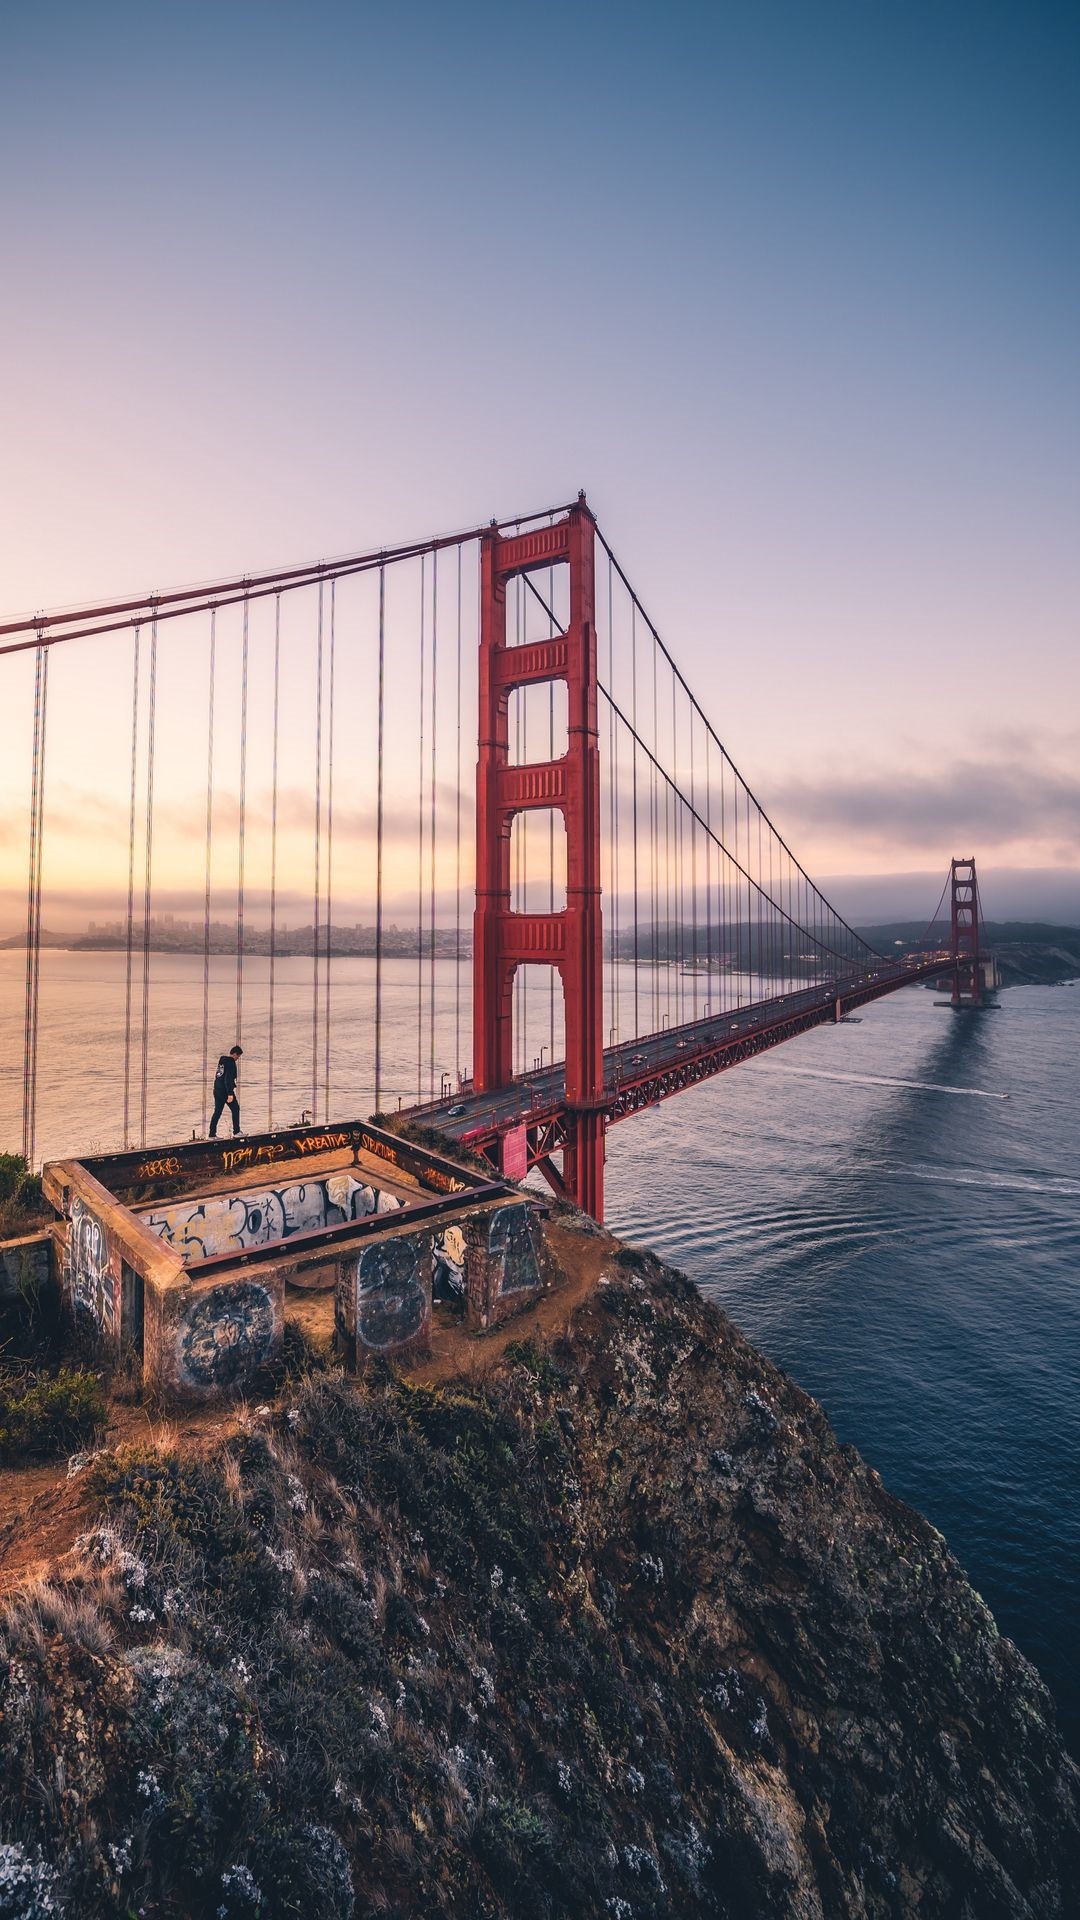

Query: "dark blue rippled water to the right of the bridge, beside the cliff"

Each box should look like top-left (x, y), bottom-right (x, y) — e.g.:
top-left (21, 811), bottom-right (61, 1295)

top-left (607, 987), bottom-right (1080, 1753)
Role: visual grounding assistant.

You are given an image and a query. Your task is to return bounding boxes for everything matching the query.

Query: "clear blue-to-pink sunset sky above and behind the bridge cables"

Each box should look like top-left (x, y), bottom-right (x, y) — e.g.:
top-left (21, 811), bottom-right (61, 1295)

top-left (0, 0), bottom-right (1080, 924)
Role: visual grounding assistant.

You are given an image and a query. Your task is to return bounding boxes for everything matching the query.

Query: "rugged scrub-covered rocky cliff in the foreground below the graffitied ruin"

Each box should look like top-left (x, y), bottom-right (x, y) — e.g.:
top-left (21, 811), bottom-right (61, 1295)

top-left (0, 1229), bottom-right (1080, 1920)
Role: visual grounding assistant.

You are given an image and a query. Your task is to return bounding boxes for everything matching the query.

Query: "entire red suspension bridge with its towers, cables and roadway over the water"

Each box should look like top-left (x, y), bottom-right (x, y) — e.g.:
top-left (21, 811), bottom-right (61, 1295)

top-left (0, 495), bottom-right (984, 1219)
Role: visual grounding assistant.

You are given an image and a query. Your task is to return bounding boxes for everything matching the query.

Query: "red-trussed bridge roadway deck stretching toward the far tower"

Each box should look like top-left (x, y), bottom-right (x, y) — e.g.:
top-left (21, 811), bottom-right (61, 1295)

top-left (409, 950), bottom-right (955, 1173)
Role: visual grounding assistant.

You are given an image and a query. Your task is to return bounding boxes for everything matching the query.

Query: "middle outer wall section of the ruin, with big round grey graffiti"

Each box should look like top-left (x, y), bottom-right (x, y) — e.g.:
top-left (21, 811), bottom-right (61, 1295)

top-left (334, 1229), bottom-right (432, 1367)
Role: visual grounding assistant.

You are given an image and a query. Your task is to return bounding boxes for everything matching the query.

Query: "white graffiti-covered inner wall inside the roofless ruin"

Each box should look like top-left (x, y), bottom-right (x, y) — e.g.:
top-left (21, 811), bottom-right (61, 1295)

top-left (140, 1173), bottom-right (404, 1263)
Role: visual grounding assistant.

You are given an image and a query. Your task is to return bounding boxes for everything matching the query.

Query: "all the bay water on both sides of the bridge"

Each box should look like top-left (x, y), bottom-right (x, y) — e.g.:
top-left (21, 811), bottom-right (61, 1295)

top-left (0, 952), bottom-right (1080, 1753)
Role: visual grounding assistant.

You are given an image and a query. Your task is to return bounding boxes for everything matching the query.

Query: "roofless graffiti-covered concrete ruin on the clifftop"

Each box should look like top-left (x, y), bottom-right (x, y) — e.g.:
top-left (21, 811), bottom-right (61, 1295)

top-left (42, 1121), bottom-right (546, 1402)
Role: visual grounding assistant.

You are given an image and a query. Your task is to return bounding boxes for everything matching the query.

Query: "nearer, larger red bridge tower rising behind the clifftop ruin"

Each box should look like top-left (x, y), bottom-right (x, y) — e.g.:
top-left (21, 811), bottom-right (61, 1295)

top-left (473, 495), bottom-right (603, 1219)
